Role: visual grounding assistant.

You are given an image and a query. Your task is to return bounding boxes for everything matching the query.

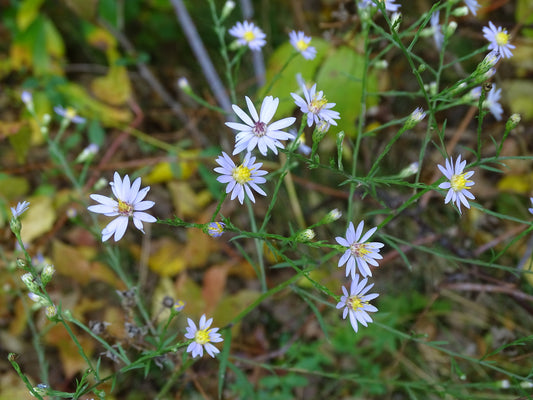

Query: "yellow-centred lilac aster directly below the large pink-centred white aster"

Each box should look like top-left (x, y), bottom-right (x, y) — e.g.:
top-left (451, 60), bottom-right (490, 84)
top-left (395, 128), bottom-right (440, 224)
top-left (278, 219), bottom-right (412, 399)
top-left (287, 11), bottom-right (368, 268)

top-left (215, 152), bottom-right (267, 204)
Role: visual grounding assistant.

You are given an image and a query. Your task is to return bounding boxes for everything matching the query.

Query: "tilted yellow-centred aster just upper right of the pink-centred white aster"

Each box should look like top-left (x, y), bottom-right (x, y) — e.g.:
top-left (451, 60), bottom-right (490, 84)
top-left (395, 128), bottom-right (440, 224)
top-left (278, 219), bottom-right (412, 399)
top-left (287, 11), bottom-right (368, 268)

top-left (291, 82), bottom-right (340, 126)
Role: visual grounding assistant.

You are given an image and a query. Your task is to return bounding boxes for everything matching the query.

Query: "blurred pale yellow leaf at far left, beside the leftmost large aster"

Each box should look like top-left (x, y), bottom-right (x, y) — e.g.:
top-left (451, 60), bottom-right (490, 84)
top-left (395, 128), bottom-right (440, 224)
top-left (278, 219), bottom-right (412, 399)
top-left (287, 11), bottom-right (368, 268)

top-left (20, 196), bottom-right (56, 243)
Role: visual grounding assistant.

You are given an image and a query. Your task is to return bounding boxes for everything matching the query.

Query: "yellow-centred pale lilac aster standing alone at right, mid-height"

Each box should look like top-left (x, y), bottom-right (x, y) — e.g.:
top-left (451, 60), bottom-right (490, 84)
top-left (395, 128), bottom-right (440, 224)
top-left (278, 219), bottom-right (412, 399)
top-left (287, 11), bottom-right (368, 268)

top-left (438, 156), bottom-right (475, 214)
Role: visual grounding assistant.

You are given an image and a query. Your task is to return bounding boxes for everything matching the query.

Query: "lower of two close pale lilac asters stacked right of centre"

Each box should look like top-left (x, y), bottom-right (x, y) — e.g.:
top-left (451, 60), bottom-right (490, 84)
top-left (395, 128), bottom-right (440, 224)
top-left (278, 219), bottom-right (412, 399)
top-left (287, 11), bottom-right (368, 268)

top-left (336, 275), bottom-right (379, 333)
